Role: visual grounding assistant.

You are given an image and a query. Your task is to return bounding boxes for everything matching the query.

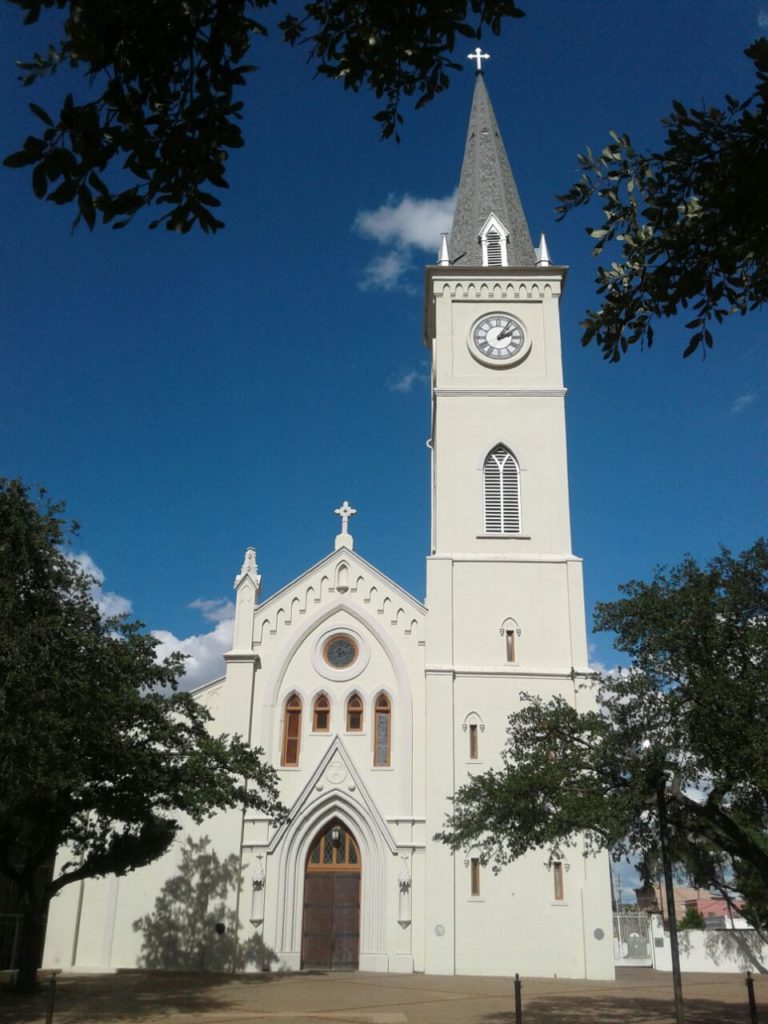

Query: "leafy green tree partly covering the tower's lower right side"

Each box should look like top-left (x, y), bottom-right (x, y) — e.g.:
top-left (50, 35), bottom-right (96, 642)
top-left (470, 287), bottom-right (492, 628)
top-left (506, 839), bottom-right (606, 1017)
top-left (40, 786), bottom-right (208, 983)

top-left (437, 540), bottom-right (768, 907)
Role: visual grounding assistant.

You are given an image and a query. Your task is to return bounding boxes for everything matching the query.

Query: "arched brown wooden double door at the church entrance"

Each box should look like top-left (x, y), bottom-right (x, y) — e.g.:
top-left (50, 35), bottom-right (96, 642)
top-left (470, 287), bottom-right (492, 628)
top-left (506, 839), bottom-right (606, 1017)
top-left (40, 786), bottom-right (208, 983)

top-left (301, 821), bottom-right (360, 971)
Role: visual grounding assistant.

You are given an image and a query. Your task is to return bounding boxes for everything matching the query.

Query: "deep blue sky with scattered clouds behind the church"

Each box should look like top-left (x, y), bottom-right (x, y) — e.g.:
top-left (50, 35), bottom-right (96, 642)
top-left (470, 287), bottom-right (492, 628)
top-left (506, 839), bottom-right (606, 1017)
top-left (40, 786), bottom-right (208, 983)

top-left (0, 0), bottom-right (768, 712)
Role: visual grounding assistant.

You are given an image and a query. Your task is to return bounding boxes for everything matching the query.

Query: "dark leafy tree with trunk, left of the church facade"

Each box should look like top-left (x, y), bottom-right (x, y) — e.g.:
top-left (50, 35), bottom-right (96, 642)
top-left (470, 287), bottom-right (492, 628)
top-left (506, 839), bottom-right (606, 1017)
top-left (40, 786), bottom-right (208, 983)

top-left (0, 479), bottom-right (282, 988)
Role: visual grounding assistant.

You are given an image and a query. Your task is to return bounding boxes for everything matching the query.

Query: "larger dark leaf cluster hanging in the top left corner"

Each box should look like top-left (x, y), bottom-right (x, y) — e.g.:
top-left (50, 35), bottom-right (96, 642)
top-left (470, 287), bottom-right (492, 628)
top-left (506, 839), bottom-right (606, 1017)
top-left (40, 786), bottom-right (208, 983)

top-left (5, 0), bottom-right (265, 231)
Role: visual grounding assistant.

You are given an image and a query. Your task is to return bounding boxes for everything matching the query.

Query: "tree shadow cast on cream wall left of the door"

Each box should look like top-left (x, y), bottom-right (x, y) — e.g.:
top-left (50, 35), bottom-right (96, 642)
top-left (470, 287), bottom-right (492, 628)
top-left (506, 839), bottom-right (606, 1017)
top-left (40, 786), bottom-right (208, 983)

top-left (133, 836), bottom-right (278, 972)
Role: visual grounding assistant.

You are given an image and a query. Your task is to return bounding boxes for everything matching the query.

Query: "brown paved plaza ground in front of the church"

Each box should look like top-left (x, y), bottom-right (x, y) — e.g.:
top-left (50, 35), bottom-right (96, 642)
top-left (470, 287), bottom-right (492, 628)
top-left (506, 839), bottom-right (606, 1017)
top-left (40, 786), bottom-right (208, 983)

top-left (0, 968), bottom-right (768, 1024)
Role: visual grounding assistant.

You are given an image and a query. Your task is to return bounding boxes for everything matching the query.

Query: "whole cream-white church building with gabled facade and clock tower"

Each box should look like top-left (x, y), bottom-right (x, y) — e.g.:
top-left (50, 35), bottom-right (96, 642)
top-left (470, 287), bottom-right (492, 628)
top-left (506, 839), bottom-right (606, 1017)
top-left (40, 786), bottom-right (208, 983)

top-left (44, 70), bottom-right (613, 979)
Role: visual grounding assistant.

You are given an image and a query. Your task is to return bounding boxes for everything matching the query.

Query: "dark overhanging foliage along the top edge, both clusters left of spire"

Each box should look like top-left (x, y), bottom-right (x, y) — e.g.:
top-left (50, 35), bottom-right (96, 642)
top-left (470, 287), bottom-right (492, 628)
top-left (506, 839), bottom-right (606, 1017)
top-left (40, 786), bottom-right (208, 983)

top-left (5, 0), bottom-right (522, 231)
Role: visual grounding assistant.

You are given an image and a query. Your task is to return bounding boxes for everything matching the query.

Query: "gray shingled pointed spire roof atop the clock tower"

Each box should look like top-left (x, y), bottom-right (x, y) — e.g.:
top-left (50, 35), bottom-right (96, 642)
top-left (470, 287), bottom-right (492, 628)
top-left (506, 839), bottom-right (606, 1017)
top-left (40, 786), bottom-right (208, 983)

top-left (450, 72), bottom-right (536, 266)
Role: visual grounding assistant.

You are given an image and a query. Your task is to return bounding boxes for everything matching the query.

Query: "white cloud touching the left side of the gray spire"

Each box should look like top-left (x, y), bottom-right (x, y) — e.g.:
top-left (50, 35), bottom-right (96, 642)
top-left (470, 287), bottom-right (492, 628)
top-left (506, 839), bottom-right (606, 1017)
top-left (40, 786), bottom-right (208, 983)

top-left (353, 195), bottom-right (456, 291)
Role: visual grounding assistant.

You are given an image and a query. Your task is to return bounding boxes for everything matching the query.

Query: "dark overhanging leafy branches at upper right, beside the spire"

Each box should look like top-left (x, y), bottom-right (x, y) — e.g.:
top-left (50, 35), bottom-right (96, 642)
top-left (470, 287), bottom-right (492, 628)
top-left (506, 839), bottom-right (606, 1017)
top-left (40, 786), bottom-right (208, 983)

top-left (557, 38), bottom-right (768, 362)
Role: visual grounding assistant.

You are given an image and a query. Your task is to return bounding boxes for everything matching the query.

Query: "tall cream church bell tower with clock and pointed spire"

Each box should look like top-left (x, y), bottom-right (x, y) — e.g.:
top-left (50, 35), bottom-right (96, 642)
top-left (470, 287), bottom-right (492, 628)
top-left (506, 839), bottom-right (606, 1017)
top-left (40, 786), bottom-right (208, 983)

top-left (425, 54), bottom-right (612, 977)
